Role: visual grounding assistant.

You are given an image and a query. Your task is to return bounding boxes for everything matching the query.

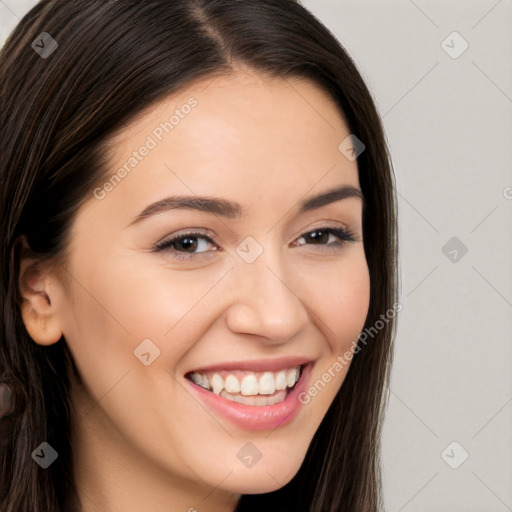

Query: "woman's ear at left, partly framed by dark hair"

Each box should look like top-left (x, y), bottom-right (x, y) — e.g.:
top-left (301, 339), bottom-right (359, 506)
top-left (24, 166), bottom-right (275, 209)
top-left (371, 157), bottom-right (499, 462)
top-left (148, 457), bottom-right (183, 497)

top-left (15, 235), bottom-right (62, 345)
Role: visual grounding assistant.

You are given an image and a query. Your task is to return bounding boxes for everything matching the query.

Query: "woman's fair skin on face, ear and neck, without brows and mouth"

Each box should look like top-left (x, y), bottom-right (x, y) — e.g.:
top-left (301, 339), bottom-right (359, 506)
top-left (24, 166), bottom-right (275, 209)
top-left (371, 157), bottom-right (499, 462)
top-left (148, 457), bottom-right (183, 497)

top-left (20, 70), bottom-right (370, 512)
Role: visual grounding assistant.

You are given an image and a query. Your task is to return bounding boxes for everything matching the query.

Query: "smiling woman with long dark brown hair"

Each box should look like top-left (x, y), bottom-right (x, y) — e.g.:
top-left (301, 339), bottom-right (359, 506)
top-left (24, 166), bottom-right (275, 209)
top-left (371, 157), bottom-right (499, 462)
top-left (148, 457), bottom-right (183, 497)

top-left (0, 0), bottom-right (396, 512)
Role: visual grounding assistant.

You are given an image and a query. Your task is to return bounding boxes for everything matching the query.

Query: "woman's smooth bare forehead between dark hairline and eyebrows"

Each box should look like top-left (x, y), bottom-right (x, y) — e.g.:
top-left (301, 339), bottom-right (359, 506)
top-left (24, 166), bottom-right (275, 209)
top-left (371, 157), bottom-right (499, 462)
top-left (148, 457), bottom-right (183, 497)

top-left (89, 71), bottom-right (358, 222)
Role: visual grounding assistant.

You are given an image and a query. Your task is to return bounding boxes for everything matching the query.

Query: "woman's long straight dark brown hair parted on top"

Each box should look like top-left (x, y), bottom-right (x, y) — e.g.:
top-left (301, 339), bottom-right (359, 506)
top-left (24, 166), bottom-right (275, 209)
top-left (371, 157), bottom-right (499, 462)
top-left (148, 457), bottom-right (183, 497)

top-left (0, 0), bottom-right (397, 512)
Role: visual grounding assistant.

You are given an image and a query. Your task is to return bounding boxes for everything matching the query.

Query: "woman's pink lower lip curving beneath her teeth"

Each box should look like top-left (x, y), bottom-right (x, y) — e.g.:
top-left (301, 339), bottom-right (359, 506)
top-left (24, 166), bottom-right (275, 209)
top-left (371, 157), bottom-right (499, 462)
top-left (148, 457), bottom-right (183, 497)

top-left (185, 363), bottom-right (312, 430)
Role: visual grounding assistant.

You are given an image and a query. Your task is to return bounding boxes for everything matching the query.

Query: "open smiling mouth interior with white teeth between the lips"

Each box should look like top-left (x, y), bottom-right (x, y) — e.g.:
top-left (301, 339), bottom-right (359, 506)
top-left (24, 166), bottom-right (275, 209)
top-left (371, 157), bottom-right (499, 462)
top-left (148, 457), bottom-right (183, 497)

top-left (185, 365), bottom-right (306, 406)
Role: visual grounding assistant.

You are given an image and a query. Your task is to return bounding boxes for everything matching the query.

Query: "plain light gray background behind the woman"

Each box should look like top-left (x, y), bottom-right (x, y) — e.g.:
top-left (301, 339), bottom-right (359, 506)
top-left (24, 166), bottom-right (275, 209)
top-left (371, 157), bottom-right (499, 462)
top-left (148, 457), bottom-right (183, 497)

top-left (0, 0), bottom-right (512, 512)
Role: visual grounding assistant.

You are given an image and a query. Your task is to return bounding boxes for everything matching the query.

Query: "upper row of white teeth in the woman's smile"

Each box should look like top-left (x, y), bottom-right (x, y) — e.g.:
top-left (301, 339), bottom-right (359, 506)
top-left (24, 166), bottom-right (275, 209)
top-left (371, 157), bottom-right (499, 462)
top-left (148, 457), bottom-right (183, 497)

top-left (190, 366), bottom-right (300, 396)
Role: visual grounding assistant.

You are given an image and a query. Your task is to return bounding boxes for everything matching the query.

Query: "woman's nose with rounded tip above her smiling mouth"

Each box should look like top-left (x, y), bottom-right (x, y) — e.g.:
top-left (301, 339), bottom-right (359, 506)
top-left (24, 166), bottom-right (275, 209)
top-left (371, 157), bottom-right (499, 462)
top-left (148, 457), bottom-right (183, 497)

top-left (227, 252), bottom-right (309, 343)
